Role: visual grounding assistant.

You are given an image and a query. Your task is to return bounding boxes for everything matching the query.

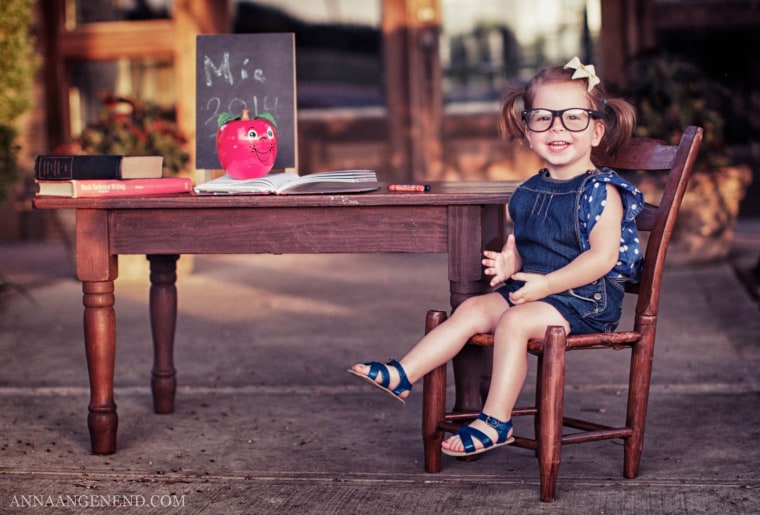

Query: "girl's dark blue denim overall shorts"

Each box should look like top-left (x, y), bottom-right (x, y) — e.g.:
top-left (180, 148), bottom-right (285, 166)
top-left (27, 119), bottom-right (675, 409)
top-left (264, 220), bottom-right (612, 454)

top-left (497, 170), bottom-right (625, 334)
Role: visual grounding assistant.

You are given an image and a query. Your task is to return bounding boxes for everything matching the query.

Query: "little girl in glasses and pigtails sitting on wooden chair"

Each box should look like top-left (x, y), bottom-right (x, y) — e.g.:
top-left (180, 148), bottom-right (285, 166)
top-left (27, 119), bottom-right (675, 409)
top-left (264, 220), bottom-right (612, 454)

top-left (349, 57), bottom-right (643, 456)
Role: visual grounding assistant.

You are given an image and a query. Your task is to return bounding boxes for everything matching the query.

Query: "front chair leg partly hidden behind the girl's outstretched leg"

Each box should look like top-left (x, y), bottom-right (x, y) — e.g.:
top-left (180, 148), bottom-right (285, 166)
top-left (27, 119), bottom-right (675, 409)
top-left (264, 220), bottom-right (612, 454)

top-left (422, 310), bottom-right (446, 473)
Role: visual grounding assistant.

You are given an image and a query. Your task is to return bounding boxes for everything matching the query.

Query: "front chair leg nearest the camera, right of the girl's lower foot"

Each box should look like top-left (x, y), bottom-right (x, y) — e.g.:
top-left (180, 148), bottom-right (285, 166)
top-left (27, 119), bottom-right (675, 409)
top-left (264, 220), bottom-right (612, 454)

top-left (537, 326), bottom-right (566, 502)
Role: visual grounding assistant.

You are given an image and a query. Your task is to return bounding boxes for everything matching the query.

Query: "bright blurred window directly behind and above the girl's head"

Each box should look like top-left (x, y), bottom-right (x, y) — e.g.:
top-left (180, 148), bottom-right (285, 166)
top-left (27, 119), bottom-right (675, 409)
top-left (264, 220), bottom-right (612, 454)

top-left (440, 0), bottom-right (601, 102)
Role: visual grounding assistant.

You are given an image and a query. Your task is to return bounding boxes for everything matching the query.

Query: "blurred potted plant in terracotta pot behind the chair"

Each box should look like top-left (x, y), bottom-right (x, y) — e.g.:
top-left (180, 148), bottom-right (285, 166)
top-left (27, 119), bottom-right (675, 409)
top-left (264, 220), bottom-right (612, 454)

top-left (624, 56), bottom-right (752, 262)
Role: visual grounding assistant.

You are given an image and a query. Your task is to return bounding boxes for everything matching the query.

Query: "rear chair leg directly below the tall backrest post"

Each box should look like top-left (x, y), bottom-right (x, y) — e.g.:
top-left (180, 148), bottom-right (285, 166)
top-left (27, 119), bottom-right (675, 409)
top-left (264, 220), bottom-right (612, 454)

top-left (623, 323), bottom-right (655, 479)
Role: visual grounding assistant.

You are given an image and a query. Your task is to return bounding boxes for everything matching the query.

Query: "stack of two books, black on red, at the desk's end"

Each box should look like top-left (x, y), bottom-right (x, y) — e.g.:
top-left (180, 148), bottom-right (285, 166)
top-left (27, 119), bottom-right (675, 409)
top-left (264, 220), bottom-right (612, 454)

top-left (34, 155), bottom-right (193, 198)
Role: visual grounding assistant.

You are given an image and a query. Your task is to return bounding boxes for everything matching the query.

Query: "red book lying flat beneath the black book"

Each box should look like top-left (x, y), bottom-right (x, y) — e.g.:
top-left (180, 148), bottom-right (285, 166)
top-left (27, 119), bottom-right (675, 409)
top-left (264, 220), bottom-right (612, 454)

top-left (36, 177), bottom-right (193, 198)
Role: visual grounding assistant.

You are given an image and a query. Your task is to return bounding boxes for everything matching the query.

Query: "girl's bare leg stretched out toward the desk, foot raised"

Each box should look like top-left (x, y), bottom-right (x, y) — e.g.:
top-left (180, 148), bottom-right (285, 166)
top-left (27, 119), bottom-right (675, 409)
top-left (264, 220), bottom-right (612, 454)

top-left (351, 293), bottom-right (509, 398)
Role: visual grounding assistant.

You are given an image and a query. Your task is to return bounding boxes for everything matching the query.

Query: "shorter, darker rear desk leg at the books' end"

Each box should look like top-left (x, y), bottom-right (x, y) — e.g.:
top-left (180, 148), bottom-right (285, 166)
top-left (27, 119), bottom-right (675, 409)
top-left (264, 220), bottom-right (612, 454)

top-left (148, 254), bottom-right (179, 413)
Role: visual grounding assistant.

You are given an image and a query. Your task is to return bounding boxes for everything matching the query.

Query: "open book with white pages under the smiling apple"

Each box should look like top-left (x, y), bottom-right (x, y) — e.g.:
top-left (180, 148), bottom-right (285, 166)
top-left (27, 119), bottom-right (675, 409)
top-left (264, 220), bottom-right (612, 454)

top-left (195, 170), bottom-right (380, 195)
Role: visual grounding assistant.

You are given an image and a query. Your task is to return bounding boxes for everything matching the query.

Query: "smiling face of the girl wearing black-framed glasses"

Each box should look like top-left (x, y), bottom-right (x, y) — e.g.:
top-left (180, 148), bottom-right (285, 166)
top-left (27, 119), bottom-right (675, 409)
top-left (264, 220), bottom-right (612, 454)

top-left (525, 80), bottom-right (604, 179)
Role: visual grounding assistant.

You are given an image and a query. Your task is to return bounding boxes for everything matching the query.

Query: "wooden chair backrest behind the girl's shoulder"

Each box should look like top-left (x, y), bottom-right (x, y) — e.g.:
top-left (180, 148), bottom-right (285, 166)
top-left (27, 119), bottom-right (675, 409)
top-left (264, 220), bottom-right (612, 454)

top-left (594, 126), bottom-right (702, 319)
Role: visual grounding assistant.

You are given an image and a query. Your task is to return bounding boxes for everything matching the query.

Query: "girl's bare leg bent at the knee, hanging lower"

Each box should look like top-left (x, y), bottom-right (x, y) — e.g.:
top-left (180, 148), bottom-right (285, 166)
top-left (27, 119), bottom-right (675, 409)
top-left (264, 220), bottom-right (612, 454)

top-left (442, 302), bottom-right (569, 451)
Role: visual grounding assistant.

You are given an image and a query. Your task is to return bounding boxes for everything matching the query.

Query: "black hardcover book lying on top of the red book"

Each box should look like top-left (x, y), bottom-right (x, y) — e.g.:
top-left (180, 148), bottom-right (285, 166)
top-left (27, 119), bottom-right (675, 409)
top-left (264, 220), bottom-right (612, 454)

top-left (34, 154), bottom-right (164, 181)
